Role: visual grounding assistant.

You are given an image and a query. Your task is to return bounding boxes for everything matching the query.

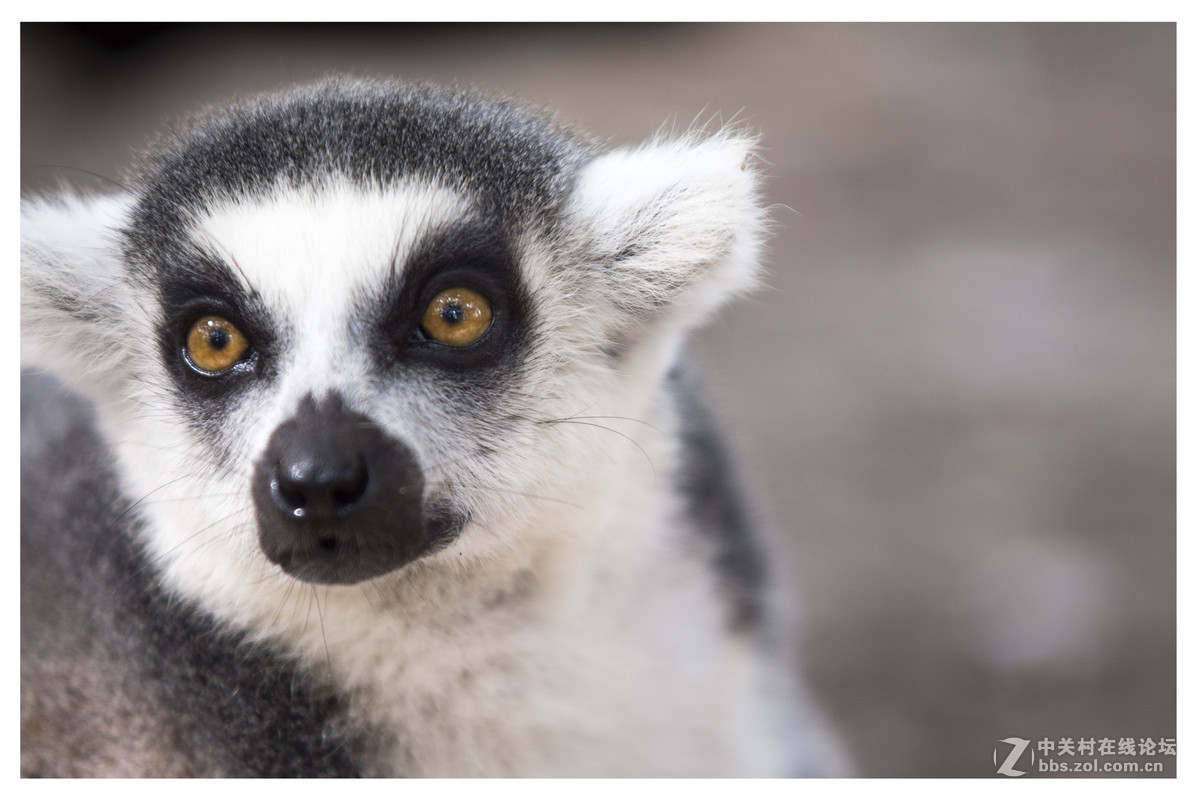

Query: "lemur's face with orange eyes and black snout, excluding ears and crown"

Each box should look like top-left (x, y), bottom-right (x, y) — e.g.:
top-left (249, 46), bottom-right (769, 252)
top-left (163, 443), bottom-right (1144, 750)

top-left (146, 178), bottom-right (545, 583)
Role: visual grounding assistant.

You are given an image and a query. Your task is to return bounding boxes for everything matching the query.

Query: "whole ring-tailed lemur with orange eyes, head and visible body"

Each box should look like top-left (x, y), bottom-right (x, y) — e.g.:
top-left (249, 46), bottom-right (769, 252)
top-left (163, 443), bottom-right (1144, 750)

top-left (22, 79), bottom-right (836, 776)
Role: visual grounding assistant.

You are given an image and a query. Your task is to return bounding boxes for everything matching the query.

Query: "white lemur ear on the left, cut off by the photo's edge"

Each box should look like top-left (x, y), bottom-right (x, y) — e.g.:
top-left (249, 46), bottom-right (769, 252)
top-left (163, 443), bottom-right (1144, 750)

top-left (20, 196), bottom-right (137, 399)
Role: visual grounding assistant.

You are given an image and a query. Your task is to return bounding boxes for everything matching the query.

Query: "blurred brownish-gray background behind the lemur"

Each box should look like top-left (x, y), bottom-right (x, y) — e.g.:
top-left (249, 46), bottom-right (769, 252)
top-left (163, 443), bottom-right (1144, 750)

top-left (20, 24), bottom-right (1176, 776)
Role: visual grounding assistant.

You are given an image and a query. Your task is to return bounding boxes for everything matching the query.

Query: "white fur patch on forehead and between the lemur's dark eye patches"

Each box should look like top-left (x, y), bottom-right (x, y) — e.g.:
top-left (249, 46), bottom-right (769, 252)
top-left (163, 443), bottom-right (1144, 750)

top-left (191, 181), bottom-right (470, 461)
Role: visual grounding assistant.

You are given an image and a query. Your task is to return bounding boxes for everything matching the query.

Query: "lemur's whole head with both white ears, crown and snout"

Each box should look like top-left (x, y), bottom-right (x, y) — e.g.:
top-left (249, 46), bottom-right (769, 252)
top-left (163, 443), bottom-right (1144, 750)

top-left (22, 80), bottom-right (762, 594)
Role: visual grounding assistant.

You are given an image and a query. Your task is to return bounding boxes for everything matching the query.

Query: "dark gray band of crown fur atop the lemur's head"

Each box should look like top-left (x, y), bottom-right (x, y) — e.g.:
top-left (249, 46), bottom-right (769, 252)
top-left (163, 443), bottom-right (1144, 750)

top-left (130, 78), bottom-right (592, 263)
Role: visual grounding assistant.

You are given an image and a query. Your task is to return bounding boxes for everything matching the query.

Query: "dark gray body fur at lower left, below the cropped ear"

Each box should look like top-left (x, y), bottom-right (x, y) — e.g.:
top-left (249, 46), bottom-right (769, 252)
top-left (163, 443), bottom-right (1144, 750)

top-left (20, 374), bottom-right (356, 777)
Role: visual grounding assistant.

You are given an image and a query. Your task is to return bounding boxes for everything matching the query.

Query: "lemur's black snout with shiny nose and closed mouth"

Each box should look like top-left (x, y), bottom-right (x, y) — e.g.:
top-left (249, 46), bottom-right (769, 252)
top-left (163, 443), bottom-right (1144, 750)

top-left (253, 395), bottom-right (466, 584)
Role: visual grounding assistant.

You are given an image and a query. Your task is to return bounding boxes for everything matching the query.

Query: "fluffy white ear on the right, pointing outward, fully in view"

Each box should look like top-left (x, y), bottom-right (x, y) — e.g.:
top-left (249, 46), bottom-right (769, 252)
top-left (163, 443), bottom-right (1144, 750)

top-left (568, 133), bottom-right (766, 345)
